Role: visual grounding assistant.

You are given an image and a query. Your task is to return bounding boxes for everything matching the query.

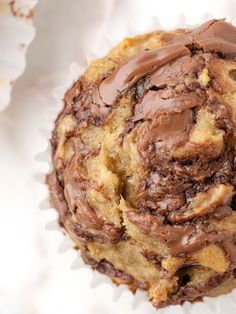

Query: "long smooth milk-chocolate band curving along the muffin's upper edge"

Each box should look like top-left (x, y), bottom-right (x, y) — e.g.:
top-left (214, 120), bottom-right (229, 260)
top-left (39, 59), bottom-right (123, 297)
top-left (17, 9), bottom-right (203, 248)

top-left (99, 20), bottom-right (236, 110)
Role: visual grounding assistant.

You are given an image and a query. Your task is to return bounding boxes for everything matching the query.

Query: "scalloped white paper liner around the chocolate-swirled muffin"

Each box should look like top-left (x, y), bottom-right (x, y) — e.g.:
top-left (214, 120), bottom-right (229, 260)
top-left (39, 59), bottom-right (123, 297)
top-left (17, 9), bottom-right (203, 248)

top-left (35, 13), bottom-right (236, 314)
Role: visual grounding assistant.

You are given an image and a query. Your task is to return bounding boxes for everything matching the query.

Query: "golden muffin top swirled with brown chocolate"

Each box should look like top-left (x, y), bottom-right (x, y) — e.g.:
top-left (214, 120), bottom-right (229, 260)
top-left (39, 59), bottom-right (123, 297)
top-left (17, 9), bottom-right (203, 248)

top-left (47, 20), bottom-right (236, 308)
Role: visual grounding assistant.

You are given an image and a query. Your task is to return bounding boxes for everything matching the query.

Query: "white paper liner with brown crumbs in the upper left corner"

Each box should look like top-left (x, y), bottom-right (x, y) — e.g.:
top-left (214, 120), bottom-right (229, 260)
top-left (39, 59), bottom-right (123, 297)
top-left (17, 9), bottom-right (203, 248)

top-left (0, 0), bottom-right (37, 111)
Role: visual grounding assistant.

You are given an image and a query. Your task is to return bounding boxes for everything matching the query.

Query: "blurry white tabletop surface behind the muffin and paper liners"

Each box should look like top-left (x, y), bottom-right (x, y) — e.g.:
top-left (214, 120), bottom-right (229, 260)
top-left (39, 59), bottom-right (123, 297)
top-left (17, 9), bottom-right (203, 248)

top-left (0, 0), bottom-right (236, 314)
